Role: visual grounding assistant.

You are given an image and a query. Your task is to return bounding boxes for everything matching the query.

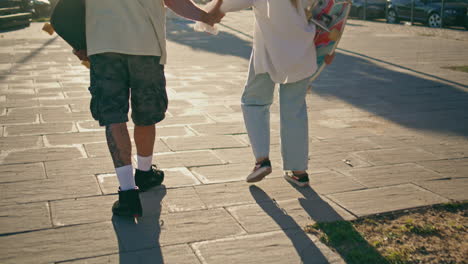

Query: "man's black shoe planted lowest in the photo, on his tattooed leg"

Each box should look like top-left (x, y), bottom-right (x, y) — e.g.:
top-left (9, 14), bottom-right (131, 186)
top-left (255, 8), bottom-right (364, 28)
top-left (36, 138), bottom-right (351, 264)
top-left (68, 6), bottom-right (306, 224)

top-left (112, 188), bottom-right (143, 217)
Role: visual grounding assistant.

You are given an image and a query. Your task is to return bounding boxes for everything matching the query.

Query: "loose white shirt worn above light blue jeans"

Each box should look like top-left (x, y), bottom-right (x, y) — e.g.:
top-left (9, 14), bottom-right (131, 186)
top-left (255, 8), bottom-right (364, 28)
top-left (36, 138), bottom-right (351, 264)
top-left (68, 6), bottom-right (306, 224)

top-left (221, 0), bottom-right (317, 83)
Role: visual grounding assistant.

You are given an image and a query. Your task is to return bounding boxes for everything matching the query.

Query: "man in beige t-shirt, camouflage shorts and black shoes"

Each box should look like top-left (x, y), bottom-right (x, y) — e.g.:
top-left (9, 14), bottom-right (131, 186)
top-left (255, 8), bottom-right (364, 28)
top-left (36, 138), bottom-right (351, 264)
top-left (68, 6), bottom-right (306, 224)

top-left (74, 0), bottom-right (224, 216)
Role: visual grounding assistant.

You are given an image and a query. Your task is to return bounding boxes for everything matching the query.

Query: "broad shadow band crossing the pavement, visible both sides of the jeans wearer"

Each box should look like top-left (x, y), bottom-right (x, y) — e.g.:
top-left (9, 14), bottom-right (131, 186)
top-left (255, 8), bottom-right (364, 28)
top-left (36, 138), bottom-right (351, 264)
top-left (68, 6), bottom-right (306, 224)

top-left (167, 19), bottom-right (468, 136)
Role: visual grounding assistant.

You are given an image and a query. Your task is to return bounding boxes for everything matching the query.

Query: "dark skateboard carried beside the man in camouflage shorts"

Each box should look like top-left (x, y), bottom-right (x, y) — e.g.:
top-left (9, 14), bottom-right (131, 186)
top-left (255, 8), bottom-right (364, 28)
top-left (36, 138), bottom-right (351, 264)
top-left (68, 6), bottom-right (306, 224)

top-left (43, 0), bottom-right (88, 67)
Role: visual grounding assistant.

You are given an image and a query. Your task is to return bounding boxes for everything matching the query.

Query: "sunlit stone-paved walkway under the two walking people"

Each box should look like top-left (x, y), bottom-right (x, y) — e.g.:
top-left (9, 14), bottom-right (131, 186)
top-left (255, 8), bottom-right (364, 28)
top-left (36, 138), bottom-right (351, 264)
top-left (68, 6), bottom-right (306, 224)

top-left (0, 11), bottom-right (468, 264)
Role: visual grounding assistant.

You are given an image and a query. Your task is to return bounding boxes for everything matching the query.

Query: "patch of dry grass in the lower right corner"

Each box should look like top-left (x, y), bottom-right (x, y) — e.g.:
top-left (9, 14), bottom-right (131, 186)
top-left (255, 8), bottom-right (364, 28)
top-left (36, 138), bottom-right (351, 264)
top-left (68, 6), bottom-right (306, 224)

top-left (306, 202), bottom-right (468, 264)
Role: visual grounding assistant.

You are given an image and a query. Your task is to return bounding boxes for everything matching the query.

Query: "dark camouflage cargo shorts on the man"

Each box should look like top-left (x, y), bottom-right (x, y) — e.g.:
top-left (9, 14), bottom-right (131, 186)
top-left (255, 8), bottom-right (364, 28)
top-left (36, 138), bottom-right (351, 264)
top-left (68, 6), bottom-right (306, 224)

top-left (89, 53), bottom-right (168, 126)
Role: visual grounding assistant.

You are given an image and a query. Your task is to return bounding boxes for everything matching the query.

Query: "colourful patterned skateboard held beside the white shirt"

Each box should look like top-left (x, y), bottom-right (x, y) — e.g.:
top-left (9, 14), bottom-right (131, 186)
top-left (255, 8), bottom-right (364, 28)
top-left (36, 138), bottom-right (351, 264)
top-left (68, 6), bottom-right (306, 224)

top-left (306, 0), bottom-right (351, 81)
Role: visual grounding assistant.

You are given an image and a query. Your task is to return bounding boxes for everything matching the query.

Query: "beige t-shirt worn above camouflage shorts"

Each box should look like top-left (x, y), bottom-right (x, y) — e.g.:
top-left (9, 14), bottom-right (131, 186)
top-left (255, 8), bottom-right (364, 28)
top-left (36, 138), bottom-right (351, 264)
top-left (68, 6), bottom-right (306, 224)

top-left (86, 0), bottom-right (166, 64)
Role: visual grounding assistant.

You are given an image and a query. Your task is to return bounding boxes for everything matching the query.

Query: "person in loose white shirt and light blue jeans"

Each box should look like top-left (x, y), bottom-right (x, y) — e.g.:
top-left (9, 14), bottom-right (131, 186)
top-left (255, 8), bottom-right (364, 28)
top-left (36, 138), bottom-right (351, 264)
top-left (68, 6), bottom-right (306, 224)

top-left (199, 0), bottom-right (324, 186)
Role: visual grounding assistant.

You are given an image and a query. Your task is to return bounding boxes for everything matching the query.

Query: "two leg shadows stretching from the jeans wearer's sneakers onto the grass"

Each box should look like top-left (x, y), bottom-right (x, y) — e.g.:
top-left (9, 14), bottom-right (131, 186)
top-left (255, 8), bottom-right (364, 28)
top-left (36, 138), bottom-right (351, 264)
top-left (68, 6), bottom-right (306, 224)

top-left (249, 185), bottom-right (388, 264)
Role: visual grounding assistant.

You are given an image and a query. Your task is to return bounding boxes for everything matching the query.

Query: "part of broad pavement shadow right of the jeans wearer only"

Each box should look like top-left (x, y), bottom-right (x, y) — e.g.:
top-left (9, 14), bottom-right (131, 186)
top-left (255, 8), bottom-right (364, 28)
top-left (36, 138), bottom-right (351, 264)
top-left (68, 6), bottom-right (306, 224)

top-left (310, 53), bottom-right (468, 136)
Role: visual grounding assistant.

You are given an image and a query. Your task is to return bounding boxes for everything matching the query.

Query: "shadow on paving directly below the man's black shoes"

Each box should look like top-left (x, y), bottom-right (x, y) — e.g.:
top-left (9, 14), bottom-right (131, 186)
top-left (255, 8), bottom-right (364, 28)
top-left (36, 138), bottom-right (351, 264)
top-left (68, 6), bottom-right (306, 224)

top-left (112, 186), bottom-right (166, 264)
